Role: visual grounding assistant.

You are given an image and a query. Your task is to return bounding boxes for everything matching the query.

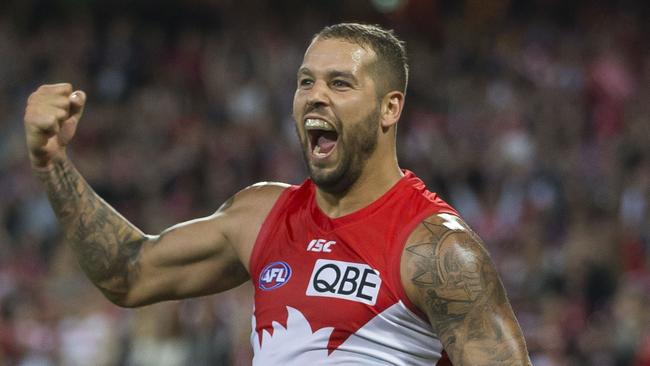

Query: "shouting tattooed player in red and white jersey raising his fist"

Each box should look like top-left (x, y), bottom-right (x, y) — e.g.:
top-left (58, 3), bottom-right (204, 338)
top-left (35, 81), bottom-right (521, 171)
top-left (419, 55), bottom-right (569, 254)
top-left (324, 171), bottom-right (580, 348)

top-left (25, 24), bottom-right (530, 365)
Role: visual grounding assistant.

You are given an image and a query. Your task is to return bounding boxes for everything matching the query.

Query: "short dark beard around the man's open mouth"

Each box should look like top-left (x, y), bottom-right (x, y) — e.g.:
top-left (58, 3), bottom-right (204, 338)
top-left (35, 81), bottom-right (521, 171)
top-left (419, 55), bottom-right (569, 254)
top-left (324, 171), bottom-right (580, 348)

top-left (301, 107), bottom-right (379, 194)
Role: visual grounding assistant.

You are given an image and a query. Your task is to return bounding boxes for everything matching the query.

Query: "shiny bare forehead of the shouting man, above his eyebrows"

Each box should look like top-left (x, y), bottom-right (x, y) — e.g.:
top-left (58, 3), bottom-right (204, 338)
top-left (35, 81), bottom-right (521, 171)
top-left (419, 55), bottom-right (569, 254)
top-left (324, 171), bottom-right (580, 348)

top-left (300, 38), bottom-right (376, 74)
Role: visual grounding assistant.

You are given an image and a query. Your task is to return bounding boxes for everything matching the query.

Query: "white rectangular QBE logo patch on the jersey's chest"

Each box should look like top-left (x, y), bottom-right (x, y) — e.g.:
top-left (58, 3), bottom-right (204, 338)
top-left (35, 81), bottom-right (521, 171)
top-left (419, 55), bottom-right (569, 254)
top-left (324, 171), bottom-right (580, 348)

top-left (306, 259), bottom-right (381, 305)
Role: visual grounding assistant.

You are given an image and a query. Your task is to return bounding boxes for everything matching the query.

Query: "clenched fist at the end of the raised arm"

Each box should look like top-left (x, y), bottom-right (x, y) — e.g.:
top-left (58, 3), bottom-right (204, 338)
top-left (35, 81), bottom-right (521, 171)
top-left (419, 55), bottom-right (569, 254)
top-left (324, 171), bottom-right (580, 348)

top-left (24, 83), bottom-right (86, 168)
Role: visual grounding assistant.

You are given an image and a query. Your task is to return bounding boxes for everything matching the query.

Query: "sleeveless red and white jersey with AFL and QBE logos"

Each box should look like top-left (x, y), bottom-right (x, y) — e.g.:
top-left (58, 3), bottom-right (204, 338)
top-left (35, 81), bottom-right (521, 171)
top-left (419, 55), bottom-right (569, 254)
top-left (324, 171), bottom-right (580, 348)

top-left (250, 171), bottom-right (457, 366)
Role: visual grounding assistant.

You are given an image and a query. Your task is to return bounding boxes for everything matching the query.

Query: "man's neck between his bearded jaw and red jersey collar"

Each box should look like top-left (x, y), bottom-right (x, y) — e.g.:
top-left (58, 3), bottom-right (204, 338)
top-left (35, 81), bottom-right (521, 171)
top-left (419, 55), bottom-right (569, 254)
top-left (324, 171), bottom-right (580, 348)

top-left (316, 155), bottom-right (404, 218)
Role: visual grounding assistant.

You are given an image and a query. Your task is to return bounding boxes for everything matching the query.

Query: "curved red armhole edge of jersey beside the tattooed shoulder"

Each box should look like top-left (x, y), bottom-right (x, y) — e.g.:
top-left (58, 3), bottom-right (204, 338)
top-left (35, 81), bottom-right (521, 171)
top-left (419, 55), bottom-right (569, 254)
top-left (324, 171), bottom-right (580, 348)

top-left (389, 207), bottom-right (458, 323)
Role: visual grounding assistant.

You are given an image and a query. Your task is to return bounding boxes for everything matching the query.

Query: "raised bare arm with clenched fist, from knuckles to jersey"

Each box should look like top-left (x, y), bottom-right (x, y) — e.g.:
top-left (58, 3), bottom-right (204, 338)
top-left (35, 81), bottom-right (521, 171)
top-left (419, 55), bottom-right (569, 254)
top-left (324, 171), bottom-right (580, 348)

top-left (25, 84), bottom-right (283, 306)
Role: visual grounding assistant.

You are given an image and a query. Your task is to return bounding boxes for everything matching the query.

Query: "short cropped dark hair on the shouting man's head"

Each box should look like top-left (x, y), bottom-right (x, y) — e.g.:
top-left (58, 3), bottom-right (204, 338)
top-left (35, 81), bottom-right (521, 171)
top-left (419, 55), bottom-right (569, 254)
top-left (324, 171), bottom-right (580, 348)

top-left (312, 23), bottom-right (409, 94)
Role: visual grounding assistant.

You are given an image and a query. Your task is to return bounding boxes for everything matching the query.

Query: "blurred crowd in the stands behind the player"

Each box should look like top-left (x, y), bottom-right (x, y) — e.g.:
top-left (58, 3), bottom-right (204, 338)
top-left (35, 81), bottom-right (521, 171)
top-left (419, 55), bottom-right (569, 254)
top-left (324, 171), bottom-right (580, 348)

top-left (0, 0), bottom-right (650, 366)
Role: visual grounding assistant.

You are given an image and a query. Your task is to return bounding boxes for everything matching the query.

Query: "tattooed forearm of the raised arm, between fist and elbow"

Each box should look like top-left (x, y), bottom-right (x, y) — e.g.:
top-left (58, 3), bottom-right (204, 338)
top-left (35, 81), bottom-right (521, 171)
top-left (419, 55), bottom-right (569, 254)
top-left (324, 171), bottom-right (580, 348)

top-left (36, 159), bottom-right (148, 302)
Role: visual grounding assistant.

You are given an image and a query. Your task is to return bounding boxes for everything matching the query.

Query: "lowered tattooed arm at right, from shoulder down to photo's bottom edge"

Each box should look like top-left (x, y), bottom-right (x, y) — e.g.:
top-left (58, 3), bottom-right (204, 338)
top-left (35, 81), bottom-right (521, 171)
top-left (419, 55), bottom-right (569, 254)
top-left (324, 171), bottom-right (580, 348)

top-left (401, 214), bottom-right (531, 366)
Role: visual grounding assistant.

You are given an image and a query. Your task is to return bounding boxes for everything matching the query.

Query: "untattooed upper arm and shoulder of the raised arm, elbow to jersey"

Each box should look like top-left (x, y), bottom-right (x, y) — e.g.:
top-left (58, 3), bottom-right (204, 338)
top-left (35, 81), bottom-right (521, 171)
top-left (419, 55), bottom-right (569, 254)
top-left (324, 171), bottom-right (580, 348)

top-left (121, 183), bottom-right (287, 306)
